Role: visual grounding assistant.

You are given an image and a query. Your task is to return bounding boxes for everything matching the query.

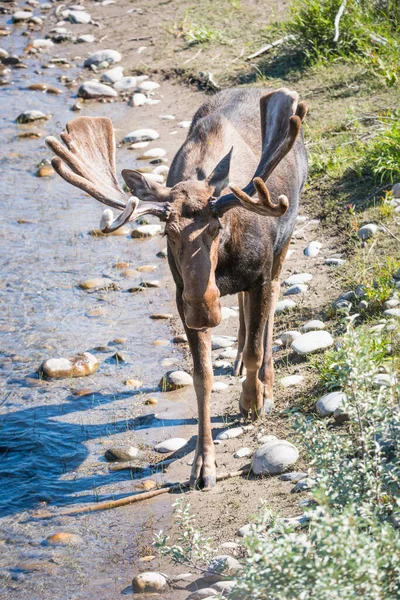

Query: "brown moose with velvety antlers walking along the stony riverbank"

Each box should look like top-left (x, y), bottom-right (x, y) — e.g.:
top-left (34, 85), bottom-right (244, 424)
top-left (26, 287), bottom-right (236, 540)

top-left (46, 88), bottom-right (307, 490)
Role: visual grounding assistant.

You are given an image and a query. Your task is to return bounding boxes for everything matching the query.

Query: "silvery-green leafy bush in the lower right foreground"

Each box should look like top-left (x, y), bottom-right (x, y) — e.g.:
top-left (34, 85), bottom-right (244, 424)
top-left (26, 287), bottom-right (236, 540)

top-left (156, 327), bottom-right (400, 600)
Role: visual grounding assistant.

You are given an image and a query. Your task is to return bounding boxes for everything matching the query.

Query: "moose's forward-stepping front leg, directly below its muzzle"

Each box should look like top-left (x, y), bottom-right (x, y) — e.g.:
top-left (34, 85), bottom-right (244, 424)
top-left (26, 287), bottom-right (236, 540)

top-left (177, 292), bottom-right (217, 490)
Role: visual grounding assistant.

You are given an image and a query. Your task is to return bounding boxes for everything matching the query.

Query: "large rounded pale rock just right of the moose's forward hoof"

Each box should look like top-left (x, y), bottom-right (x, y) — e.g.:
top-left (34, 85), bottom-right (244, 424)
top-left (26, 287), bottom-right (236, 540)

top-left (252, 440), bottom-right (299, 475)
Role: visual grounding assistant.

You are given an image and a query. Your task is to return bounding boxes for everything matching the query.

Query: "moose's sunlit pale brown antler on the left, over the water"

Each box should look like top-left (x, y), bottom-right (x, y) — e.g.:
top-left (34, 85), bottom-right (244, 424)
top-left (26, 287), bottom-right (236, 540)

top-left (46, 117), bottom-right (168, 233)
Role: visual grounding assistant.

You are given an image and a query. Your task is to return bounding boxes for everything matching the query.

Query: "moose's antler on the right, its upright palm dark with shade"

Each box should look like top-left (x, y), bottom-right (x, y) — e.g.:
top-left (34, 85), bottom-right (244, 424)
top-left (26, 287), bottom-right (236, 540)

top-left (213, 88), bottom-right (307, 217)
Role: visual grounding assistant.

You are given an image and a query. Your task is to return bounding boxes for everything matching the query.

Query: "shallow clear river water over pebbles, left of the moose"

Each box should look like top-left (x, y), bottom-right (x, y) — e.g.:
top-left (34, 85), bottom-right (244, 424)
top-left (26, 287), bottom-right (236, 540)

top-left (0, 7), bottom-right (200, 600)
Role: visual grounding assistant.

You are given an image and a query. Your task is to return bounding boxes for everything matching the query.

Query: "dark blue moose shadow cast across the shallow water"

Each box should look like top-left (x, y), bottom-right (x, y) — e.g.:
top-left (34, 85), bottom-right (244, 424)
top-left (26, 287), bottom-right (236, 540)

top-left (0, 390), bottom-right (206, 516)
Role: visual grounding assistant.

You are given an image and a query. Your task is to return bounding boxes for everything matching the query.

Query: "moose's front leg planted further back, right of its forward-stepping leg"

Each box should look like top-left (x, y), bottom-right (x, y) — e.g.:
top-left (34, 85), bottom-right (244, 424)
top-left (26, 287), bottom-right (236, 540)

top-left (239, 281), bottom-right (272, 420)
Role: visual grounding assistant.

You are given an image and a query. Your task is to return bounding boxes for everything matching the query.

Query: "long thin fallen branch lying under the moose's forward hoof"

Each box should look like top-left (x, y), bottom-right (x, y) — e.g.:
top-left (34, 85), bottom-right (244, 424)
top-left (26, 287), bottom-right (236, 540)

top-left (33, 468), bottom-right (250, 519)
